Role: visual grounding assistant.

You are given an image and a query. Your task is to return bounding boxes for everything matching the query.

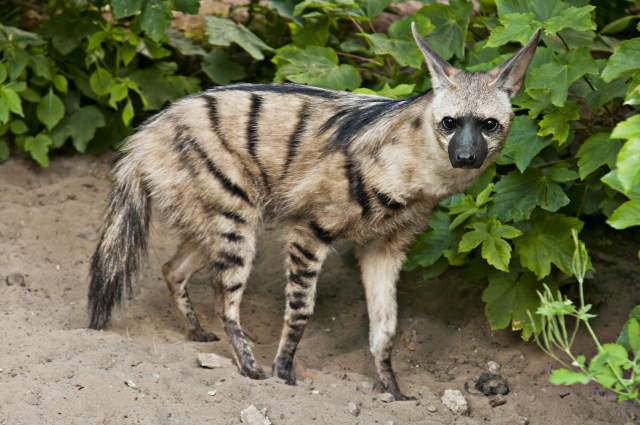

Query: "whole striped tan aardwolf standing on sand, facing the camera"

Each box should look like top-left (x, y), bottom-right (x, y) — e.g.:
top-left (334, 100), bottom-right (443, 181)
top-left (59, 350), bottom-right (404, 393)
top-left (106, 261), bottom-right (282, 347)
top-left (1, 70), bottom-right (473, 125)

top-left (89, 26), bottom-right (540, 400)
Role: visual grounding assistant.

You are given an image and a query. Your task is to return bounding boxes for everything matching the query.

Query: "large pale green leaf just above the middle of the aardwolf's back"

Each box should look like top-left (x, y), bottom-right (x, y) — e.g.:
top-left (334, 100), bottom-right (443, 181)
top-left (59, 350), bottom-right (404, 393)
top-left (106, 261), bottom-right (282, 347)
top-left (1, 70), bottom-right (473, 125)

top-left (276, 45), bottom-right (362, 90)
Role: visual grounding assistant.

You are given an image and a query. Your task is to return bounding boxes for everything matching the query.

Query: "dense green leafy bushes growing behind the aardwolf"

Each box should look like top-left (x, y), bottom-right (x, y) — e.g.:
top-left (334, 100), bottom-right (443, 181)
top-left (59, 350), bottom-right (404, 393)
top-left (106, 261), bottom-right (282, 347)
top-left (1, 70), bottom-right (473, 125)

top-left (0, 0), bottom-right (640, 352)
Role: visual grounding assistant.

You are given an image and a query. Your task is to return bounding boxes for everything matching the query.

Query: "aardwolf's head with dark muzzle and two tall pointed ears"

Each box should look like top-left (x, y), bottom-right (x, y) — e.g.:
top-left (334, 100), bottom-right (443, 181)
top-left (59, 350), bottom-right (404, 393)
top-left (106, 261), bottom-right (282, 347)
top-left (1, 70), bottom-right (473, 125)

top-left (411, 24), bottom-right (541, 168)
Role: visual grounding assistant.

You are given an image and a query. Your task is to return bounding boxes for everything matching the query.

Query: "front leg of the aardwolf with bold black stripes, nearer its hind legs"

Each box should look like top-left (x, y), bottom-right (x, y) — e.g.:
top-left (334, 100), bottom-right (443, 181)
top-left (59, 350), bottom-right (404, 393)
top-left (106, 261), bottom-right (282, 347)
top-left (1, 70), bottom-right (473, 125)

top-left (272, 225), bottom-right (329, 385)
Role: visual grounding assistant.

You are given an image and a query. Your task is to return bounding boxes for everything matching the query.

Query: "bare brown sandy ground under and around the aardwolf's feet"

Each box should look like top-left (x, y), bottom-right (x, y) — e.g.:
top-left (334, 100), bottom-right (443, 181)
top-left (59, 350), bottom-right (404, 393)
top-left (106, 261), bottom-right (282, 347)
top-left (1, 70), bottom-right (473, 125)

top-left (0, 156), bottom-right (640, 425)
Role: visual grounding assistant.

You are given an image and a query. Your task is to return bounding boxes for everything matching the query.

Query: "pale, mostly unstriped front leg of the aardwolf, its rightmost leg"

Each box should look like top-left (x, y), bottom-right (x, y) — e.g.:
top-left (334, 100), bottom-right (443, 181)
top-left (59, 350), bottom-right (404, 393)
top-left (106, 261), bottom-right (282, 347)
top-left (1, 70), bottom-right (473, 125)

top-left (359, 235), bottom-right (415, 400)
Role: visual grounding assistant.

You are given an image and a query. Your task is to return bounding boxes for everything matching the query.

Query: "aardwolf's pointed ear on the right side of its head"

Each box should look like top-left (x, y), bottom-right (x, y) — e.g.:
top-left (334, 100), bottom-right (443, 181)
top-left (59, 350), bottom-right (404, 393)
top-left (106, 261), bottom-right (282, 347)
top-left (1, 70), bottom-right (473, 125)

top-left (487, 28), bottom-right (542, 97)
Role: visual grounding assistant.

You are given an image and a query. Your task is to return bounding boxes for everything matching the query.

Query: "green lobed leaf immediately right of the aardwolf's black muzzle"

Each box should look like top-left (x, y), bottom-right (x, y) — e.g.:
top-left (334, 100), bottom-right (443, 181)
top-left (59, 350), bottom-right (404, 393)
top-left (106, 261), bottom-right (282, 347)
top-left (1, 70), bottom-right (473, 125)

top-left (498, 115), bottom-right (551, 173)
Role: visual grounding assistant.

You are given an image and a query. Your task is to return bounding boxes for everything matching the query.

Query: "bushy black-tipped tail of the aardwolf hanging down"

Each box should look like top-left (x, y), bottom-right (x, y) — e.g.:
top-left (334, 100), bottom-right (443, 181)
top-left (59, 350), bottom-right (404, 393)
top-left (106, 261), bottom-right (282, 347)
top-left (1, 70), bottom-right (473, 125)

top-left (89, 164), bottom-right (150, 329)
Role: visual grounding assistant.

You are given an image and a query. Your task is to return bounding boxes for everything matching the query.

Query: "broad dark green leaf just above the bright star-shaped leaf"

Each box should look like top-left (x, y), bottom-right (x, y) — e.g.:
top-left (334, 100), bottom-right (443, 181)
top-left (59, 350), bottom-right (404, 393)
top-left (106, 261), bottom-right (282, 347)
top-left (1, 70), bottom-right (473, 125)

top-left (489, 168), bottom-right (569, 222)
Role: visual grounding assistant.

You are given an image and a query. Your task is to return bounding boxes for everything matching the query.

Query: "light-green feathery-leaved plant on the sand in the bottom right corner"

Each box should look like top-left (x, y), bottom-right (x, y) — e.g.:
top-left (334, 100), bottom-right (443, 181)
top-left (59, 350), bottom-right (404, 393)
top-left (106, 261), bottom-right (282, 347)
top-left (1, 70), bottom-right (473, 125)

top-left (529, 231), bottom-right (640, 403)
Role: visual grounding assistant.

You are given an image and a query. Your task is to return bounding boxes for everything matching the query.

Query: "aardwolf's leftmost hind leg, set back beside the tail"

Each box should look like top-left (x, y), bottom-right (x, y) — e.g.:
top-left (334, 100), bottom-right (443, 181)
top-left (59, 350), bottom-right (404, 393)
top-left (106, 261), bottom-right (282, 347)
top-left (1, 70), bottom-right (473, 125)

top-left (162, 241), bottom-right (219, 342)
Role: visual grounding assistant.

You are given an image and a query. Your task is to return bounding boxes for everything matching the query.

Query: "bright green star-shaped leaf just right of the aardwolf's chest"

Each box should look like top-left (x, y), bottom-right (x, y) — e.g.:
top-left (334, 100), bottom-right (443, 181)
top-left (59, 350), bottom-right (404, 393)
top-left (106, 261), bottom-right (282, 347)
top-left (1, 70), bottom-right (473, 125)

top-left (458, 217), bottom-right (522, 272)
